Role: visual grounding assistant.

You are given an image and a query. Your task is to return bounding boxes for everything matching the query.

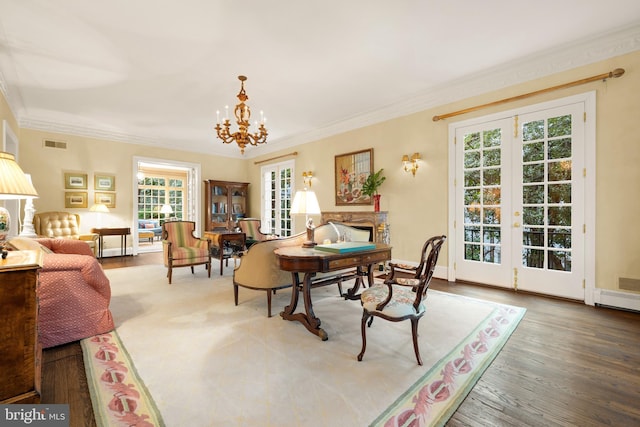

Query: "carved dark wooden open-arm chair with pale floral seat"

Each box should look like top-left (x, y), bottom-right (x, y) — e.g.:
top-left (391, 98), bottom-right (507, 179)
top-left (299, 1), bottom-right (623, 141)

top-left (358, 236), bottom-right (447, 365)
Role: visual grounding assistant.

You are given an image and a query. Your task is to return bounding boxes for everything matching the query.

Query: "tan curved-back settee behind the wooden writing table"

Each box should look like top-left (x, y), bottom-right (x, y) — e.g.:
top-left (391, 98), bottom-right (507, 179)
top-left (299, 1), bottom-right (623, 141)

top-left (233, 223), bottom-right (369, 317)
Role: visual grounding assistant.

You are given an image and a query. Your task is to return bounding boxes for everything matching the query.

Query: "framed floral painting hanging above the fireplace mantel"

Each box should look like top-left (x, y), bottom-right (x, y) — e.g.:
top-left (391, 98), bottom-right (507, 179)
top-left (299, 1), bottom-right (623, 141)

top-left (335, 148), bottom-right (373, 205)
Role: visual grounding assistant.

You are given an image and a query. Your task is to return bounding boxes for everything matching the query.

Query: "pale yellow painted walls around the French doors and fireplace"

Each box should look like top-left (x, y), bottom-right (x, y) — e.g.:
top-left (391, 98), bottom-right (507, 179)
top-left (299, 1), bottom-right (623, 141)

top-left (0, 48), bottom-right (640, 289)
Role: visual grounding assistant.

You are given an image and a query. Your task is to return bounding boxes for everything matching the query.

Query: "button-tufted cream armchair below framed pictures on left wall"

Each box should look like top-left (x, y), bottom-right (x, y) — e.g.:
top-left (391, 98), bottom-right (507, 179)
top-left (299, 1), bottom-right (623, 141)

top-left (33, 212), bottom-right (98, 256)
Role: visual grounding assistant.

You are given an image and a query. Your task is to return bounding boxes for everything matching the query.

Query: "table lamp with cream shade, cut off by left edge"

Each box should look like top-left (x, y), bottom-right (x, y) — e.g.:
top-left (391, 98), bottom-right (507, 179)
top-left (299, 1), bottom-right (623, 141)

top-left (0, 152), bottom-right (38, 258)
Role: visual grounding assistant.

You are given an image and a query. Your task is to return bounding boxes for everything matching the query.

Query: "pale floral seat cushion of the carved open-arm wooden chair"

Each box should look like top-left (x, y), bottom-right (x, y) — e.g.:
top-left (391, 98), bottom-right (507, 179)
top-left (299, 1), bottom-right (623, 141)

top-left (360, 279), bottom-right (426, 317)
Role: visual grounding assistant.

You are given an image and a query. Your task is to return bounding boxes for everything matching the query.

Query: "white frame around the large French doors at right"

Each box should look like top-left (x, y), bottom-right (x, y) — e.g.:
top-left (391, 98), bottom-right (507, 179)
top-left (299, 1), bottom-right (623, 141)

top-left (447, 91), bottom-right (596, 305)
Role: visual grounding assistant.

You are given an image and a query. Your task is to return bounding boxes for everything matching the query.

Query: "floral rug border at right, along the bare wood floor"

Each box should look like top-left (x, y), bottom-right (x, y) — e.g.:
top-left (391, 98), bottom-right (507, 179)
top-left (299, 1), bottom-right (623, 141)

top-left (370, 291), bottom-right (526, 427)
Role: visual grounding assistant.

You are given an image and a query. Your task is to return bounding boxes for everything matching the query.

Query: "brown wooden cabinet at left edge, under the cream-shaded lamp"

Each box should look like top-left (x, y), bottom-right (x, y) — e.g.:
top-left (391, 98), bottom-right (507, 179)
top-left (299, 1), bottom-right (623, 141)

top-left (0, 251), bottom-right (42, 404)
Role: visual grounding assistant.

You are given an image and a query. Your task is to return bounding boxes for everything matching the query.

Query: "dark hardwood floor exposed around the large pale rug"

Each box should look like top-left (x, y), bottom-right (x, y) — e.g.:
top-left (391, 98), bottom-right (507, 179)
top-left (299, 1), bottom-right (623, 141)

top-left (42, 253), bottom-right (640, 427)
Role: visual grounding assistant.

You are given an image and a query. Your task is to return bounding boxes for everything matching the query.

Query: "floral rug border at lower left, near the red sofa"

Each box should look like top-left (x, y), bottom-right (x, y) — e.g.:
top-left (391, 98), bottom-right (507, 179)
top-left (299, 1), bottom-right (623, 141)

top-left (80, 330), bottom-right (165, 427)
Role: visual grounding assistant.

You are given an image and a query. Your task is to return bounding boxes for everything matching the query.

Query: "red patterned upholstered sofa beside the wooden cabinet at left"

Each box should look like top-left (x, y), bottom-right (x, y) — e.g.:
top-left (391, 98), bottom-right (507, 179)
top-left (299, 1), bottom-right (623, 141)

top-left (9, 237), bottom-right (114, 348)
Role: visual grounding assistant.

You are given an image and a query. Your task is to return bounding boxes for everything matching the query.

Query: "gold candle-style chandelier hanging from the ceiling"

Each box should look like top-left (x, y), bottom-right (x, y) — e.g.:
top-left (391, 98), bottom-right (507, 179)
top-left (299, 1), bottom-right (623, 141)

top-left (216, 76), bottom-right (267, 154)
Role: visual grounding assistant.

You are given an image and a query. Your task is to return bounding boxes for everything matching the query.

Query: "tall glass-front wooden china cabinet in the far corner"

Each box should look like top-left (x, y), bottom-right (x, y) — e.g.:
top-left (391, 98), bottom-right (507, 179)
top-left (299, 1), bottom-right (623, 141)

top-left (204, 179), bottom-right (249, 231)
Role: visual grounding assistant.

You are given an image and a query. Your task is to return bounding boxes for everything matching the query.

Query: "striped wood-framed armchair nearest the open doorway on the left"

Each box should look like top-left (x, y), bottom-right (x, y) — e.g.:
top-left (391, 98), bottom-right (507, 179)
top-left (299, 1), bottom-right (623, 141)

top-left (162, 221), bottom-right (211, 284)
